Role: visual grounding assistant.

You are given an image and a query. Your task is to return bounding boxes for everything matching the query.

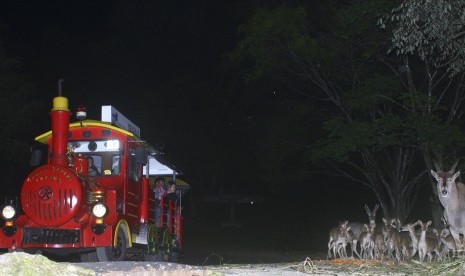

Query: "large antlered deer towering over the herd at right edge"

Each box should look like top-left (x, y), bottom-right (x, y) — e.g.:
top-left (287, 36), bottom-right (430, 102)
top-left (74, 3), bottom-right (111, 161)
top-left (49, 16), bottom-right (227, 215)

top-left (431, 161), bottom-right (465, 252)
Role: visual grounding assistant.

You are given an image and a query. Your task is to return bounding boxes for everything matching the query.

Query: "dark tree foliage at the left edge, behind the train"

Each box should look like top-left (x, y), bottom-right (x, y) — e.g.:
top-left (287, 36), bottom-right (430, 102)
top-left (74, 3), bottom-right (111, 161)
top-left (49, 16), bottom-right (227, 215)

top-left (0, 47), bottom-right (47, 196)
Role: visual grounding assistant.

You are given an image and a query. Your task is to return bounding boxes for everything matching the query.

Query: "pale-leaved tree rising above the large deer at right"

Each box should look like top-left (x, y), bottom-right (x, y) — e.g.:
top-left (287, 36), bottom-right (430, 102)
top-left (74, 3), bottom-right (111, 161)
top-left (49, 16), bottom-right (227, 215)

top-left (378, 0), bottom-right (465, 226)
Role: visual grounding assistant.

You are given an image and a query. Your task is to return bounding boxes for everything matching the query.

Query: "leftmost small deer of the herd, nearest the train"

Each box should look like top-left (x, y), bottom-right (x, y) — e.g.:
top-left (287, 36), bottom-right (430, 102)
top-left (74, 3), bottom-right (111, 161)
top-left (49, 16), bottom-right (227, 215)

top-left (328, 221), bottom-right (353, 259)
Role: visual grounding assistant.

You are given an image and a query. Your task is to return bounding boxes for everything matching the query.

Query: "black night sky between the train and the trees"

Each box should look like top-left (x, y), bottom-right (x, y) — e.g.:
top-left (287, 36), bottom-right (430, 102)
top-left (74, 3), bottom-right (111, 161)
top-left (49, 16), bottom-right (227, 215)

top-left (0, 0), bottom-right (436, 264)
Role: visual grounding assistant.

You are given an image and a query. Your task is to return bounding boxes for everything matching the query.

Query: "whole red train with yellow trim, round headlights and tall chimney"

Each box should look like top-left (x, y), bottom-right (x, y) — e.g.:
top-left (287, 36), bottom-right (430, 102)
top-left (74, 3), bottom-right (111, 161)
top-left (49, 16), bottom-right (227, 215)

top-left (0, 96), bottom-right (183, 261)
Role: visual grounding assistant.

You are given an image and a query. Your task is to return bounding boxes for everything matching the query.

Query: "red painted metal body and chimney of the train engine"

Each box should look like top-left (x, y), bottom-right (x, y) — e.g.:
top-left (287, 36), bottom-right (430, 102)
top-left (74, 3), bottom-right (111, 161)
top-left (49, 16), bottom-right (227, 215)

top-left (0, 96), bottom-right (182, 260)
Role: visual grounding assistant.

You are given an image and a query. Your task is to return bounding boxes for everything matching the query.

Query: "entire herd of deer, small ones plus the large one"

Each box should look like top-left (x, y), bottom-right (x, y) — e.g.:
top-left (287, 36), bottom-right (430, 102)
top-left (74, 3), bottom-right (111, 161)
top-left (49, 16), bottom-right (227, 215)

top-left (328, 167), bottom-right (465, 262)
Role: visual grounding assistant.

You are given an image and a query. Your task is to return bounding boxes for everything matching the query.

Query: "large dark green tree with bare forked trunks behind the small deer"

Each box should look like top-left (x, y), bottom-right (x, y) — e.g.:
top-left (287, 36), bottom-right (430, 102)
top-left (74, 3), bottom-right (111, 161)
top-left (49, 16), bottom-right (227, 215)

top-left (230, 1), bottom-right (463, 221)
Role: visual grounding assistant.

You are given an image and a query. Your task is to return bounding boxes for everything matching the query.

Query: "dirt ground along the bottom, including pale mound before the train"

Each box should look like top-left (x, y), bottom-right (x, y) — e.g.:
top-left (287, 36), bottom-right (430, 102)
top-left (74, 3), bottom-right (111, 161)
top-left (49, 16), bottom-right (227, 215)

top-left (8, 210), bottom-right (465, 276)
